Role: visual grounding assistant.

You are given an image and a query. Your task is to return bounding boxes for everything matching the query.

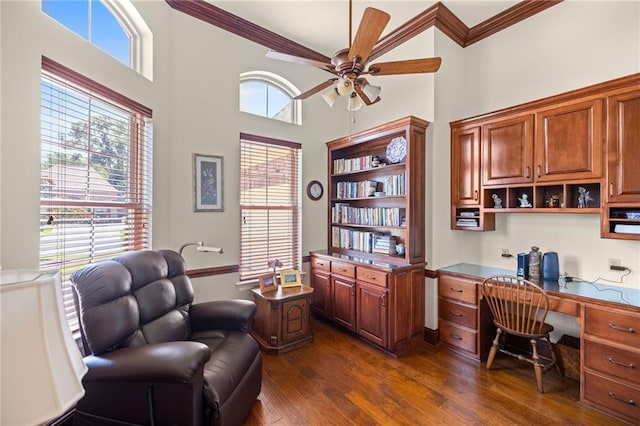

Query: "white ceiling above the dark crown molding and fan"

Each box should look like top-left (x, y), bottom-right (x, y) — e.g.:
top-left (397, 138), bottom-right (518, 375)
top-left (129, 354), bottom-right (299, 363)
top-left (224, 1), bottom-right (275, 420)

top-left (207, 0), bottom-right (520, 57)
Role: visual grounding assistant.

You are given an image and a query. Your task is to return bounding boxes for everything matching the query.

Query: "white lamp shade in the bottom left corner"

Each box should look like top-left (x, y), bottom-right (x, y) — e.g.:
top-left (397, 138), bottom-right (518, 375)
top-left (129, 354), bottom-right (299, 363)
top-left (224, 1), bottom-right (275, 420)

top-left (0, 271), bottom-right (87, 426)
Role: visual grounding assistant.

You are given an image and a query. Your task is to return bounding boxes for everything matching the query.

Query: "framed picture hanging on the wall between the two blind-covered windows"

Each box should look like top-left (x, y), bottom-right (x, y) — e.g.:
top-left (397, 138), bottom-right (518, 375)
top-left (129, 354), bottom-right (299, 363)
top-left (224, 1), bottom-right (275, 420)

top-left (193, 154), bottom-right (224, 212)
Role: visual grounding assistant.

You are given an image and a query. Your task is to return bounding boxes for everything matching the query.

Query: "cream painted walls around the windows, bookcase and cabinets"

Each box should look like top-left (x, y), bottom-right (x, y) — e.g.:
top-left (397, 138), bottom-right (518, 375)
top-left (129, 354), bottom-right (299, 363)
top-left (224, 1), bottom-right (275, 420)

top-left (0, 0), bottom-right (640, 314)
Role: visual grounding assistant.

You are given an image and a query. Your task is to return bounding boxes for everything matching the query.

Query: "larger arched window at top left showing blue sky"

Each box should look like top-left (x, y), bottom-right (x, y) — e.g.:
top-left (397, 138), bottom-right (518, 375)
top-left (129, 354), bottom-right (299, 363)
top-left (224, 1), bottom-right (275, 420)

top-left (42, 0), bottom-right (152, 79)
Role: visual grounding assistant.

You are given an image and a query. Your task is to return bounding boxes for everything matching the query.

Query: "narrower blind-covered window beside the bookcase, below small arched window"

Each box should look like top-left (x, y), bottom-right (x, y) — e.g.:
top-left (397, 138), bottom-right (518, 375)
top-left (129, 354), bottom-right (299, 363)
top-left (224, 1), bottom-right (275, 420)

top-left (240, 134), bottom-right (302, 279)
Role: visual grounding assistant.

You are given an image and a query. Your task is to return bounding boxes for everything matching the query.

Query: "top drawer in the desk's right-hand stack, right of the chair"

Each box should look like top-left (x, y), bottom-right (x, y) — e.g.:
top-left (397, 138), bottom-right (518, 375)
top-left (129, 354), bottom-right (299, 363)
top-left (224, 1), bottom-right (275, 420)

top-left (584, 306), bottom-right (640, 348)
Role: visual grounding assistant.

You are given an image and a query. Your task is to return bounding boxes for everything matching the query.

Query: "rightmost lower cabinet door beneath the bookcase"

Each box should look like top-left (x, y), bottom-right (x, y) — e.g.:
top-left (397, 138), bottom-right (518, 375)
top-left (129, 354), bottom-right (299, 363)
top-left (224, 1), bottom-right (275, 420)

top-left (356, 282), bottom-right (389, 347)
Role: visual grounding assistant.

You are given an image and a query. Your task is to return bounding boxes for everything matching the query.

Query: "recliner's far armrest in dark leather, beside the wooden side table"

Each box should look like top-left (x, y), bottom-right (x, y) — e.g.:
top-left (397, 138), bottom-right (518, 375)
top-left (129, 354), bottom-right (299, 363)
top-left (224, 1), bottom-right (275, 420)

top-left (189, 299), bottom-right (256, 333)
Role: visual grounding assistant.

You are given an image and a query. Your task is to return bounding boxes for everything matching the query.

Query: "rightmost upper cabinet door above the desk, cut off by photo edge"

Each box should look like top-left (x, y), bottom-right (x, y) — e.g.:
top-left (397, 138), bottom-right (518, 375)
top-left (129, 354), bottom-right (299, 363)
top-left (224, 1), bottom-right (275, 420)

top-left (607, 90), bottom-right (640, 203)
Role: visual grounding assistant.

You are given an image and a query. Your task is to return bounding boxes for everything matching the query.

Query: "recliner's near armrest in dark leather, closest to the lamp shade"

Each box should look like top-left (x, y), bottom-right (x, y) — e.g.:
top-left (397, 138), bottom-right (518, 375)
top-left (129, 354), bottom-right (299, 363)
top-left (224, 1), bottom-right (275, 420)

top-left (83, 341), bottom-right (211, 382)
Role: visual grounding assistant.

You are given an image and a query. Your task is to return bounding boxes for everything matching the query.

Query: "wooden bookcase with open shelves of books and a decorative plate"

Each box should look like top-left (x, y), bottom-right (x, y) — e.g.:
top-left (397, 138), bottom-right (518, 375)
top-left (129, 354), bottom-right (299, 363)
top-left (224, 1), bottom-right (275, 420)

top-left (327, 117), bottom-right (428, 263)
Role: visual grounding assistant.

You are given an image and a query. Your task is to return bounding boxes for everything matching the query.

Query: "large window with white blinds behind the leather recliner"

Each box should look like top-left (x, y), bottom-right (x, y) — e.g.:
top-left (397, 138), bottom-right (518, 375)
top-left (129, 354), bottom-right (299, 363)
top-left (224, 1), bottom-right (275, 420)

top-left (40, 58), bottom-right (152, 331)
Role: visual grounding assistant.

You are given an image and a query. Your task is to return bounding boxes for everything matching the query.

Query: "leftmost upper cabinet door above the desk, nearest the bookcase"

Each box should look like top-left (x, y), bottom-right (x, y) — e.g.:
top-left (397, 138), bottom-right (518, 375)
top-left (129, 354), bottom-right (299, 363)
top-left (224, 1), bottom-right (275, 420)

top-left (451, 126), bottom-right (480, 206)
